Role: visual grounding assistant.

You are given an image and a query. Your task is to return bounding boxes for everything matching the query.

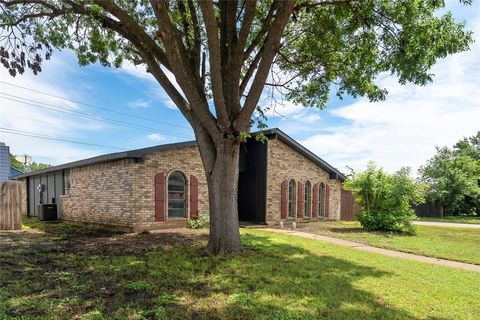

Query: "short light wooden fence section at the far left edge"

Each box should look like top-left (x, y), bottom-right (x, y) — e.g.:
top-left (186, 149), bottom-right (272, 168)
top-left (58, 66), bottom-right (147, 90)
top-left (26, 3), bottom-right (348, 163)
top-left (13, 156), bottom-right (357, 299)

top-left (0, 181), bottom-right (22, 230)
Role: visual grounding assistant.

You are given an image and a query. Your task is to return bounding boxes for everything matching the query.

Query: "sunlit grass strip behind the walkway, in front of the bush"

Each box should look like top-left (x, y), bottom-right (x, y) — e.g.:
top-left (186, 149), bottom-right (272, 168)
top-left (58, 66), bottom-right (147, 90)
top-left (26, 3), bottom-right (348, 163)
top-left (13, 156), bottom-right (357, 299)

top-left (300, 221), bottom-right (480, 264)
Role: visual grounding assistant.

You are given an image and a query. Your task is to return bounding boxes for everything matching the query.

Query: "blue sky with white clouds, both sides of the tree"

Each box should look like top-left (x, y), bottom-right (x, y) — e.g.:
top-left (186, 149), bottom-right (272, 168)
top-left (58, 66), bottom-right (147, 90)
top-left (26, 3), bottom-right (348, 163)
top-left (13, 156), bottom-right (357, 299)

top-left (0, 0), bottom-right (480, 175)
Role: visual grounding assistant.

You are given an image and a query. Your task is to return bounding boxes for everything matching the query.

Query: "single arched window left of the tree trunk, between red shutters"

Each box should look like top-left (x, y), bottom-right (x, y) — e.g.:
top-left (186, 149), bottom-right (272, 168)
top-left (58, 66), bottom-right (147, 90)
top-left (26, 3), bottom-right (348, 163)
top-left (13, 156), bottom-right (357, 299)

top-left (168, 171), bottom-right (187, 218)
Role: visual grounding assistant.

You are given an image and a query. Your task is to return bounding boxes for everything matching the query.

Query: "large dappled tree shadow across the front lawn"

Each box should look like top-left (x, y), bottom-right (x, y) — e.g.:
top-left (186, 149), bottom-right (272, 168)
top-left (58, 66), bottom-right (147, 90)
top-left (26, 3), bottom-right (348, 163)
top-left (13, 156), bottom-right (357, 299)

top-left (0, 226), bottom-right (450, 319)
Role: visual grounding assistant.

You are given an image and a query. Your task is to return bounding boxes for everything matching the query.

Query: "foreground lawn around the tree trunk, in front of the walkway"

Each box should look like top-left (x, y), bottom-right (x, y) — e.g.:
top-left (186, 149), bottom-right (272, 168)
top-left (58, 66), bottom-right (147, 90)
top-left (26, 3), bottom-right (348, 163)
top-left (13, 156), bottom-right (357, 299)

top-left (0, 221), bottom-right (480, 320)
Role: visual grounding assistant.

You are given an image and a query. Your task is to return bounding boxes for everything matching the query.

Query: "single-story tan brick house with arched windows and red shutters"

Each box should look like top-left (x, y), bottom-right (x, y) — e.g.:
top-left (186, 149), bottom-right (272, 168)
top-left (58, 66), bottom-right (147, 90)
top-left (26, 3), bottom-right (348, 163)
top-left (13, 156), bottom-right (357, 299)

top-left (17, 129), bottom-right (345, 231)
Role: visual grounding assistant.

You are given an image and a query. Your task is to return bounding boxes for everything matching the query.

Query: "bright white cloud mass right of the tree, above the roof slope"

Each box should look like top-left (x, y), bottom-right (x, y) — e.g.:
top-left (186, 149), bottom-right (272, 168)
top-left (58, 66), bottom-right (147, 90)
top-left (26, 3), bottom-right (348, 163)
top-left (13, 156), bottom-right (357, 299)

top-left (302, 14), bottom-right (480, 171)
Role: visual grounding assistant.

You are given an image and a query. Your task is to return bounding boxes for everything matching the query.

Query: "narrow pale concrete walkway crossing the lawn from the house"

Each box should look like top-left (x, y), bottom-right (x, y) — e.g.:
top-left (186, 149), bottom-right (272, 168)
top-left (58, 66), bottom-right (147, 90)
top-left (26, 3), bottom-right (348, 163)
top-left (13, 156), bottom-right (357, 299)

top-left (265, 229), bottom-right (480, 272)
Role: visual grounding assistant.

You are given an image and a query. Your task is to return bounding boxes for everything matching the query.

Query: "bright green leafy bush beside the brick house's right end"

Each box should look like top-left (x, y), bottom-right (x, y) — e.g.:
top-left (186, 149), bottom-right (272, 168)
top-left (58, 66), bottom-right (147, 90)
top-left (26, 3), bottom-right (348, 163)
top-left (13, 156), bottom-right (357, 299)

top-left (345, 162), bottom-right (424, 233)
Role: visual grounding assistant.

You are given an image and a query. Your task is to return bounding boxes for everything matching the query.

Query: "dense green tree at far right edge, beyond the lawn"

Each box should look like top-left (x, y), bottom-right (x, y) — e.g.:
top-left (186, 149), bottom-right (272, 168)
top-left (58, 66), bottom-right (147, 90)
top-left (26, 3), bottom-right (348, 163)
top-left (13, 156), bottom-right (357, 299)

top-left (419, 131), bottom-right (480, 215)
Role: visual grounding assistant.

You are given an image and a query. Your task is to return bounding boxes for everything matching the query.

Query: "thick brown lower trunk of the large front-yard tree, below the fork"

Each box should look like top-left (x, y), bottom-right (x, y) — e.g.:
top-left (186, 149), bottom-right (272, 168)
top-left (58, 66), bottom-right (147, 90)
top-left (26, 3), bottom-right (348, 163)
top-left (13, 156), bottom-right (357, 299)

top-left (197, 130), bottom-right (242, 255)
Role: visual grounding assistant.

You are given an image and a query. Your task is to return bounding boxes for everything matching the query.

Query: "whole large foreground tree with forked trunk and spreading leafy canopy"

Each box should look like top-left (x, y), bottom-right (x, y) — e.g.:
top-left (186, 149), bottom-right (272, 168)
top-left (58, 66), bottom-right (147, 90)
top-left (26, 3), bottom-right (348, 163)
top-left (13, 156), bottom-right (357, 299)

top-left (0, 0), bottom-right (471, 253)
